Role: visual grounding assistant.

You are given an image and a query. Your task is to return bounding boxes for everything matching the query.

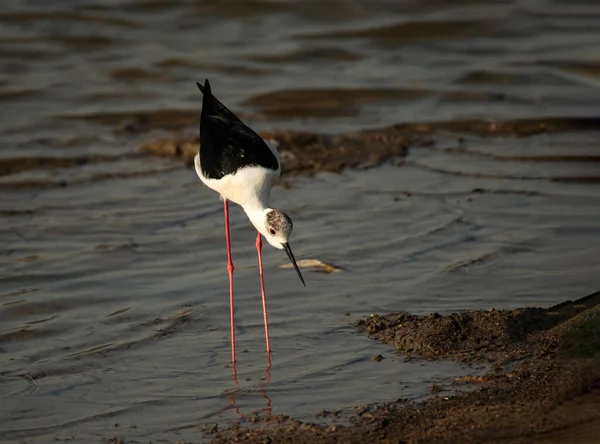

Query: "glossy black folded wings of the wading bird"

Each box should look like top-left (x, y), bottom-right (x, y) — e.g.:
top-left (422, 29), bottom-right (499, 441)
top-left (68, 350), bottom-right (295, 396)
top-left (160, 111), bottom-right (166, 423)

top-left (196, 79), bottom-right (279, 179)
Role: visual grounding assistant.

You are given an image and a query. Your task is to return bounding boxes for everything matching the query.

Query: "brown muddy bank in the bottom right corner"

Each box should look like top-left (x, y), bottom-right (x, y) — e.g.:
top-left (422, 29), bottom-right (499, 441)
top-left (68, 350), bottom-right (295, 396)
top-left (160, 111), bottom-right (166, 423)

top-left (198, 292), bottom-right (600, 443)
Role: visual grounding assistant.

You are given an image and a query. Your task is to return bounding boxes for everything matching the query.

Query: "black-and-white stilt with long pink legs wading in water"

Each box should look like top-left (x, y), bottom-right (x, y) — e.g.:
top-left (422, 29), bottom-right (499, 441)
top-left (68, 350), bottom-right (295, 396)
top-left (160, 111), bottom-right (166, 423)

top-left (194, 79), bottom-right (306, 366)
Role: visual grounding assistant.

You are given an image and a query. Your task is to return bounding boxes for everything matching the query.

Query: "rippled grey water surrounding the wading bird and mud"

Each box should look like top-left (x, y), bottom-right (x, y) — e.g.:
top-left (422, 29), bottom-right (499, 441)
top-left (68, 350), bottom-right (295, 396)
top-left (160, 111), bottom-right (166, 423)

top-left (0, 0), bottom-right (600, 443)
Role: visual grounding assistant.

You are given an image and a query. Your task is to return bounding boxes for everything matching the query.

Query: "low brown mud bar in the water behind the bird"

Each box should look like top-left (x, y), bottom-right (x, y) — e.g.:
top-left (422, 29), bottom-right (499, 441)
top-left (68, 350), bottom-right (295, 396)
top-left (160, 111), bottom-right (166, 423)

top-left (140, 117), bottom-right (600, 182)
